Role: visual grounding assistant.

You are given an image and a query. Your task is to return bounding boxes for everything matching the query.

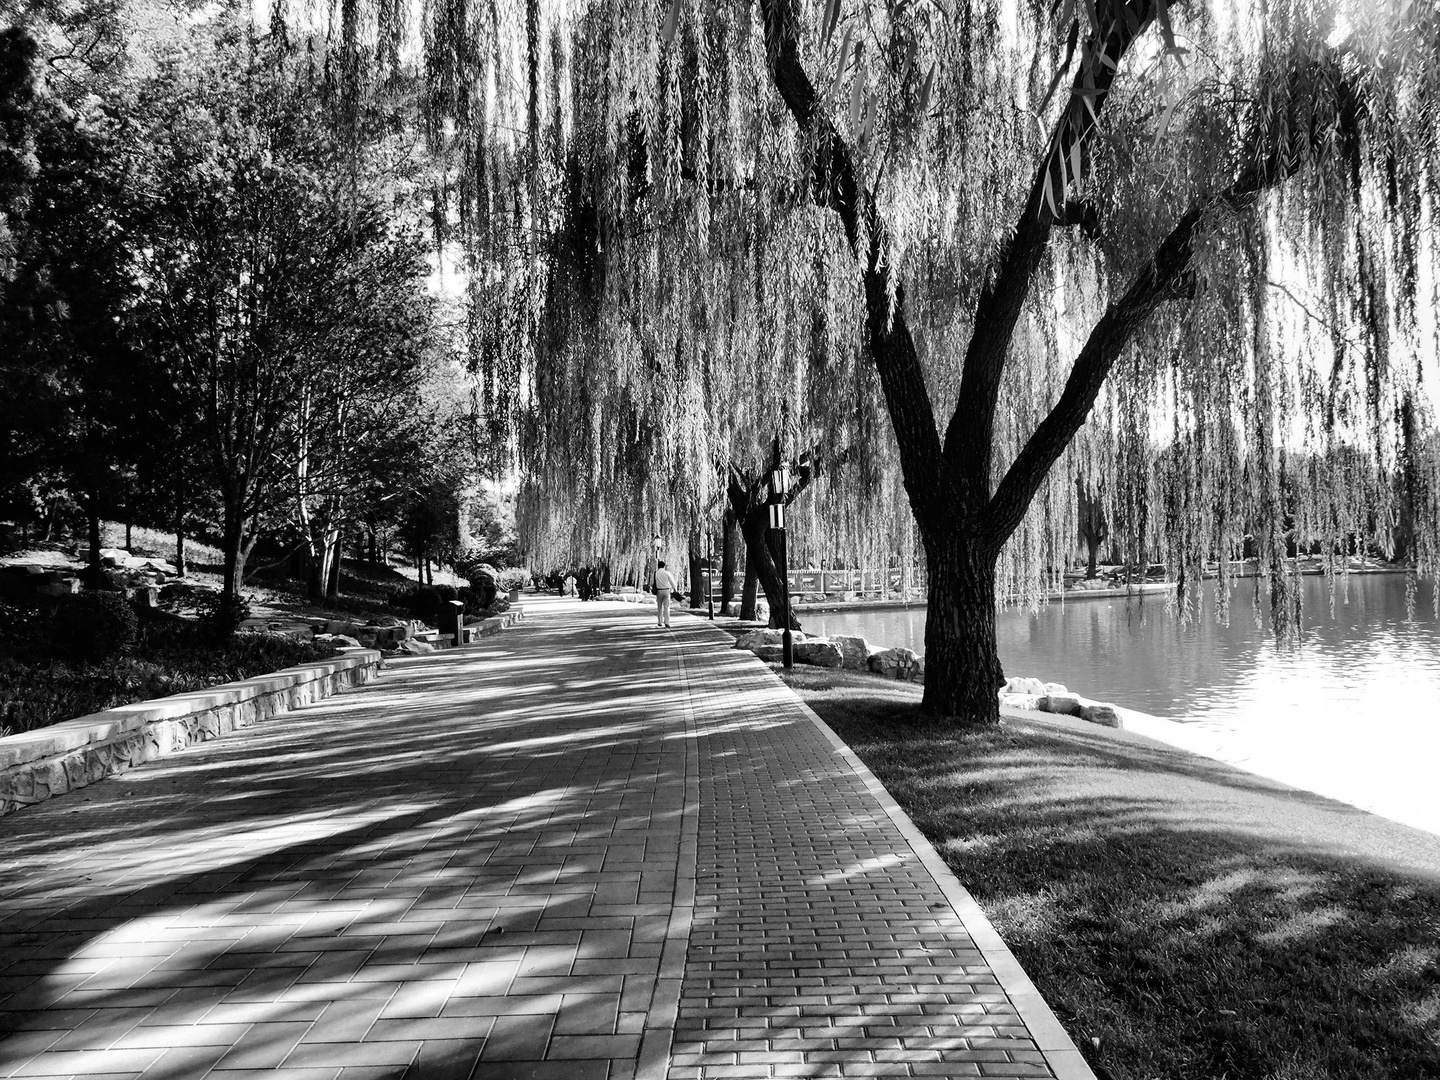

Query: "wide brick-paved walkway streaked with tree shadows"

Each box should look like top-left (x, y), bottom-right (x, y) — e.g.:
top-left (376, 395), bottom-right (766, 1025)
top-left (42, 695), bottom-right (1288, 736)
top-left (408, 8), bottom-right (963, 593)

top-left (0, 599), bottom-right (1090, 1080)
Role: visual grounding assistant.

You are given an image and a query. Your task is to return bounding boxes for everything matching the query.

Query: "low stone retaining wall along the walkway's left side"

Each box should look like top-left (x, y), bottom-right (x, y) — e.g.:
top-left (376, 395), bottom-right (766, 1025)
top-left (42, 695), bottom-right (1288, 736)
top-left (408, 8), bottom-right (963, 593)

top-left (0, 649), bottom-right (380, 816)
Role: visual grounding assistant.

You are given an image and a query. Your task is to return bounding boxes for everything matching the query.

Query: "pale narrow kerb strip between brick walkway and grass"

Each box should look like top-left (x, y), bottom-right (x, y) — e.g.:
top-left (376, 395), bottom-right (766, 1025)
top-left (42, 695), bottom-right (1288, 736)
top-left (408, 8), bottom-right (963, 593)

top-left (691, 626), bottom-right (1097, 1080)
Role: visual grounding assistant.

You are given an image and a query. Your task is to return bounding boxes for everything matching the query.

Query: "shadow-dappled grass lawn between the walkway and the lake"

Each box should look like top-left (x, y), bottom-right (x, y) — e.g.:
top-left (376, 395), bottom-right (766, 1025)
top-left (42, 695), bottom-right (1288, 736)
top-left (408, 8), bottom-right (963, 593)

top-left (786, 668), bottom-right (1440, 1080)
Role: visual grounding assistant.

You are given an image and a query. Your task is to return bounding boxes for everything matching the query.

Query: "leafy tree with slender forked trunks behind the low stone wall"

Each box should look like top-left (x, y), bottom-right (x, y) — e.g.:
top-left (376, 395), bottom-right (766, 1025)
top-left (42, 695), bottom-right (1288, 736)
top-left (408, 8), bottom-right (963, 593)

top-left (132, 22), bottom-right (433, 595)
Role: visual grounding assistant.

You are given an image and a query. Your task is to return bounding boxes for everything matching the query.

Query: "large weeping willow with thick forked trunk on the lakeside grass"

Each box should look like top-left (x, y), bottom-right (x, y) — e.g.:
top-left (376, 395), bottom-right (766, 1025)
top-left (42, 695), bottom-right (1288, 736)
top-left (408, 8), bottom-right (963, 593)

top-left (280, 0), bottom-right (1440, 723)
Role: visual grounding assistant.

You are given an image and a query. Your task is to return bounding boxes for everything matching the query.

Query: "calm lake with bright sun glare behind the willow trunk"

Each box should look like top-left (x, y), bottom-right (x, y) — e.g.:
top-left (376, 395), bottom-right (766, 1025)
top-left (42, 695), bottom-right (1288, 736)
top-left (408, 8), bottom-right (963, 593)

top-left (801, 575), bottom-right (1440, 832)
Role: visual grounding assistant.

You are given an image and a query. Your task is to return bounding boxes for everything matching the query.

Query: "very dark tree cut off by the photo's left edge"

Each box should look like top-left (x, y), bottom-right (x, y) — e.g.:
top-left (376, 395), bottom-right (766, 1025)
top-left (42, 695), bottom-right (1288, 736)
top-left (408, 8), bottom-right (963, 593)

top-left (0, 29), bottom-right (141, 572)
